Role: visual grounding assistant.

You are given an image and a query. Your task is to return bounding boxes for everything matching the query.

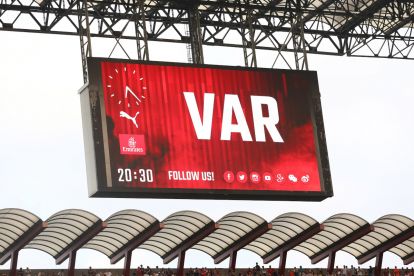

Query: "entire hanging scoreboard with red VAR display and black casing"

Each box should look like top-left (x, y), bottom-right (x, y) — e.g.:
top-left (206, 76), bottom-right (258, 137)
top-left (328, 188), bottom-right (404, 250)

top-left (80, 59), bottom-right (332, 200)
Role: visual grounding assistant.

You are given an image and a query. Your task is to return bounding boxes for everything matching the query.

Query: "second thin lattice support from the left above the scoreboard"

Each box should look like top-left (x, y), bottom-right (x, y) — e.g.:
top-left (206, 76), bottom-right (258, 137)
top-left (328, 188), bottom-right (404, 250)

top-left (134, 0), bottom-right (149, 60)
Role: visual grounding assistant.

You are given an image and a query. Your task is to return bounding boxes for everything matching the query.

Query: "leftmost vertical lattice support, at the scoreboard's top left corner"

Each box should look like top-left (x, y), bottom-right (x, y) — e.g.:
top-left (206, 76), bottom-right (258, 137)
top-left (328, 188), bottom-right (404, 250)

top-left (78, 0), bottom-right (92, 83)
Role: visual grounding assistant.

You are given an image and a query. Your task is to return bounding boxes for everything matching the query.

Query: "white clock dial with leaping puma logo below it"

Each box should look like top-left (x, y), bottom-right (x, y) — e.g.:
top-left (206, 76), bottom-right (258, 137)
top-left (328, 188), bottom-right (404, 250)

top-left (106, 66), bottom-right (147, 128)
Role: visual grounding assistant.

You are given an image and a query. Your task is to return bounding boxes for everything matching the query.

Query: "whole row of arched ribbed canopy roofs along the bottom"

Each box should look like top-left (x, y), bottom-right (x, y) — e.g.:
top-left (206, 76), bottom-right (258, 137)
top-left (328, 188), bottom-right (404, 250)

top-left (0, 209), bottom-right (414, 276)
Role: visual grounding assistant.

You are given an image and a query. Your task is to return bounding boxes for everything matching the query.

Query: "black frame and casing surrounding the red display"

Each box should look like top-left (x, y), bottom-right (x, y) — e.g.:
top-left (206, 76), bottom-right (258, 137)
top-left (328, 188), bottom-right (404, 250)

top-left (80, 58), bottom-right (333, 201)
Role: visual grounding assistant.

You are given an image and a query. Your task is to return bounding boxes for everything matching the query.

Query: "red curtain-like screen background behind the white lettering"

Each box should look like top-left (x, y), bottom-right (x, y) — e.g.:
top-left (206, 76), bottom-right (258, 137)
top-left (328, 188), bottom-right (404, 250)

top-left (101, 62), bottom-right (321, 191)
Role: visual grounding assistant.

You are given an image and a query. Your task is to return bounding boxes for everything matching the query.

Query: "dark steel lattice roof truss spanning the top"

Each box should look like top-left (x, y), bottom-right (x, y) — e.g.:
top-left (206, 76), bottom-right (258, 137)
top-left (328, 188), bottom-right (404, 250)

top-left (0, 0), bottom-right (414, 81)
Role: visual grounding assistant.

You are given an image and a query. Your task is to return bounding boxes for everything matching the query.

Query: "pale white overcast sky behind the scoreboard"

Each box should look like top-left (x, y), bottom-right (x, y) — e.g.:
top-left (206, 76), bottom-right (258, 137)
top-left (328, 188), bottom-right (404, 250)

top-left (0, 32), bottom-right (414, 269)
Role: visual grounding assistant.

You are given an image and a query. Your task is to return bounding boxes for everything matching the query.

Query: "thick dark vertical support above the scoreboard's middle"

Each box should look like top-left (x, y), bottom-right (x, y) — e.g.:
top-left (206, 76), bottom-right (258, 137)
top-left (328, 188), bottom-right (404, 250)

top-left (188, 1), bottom-right (204, 64)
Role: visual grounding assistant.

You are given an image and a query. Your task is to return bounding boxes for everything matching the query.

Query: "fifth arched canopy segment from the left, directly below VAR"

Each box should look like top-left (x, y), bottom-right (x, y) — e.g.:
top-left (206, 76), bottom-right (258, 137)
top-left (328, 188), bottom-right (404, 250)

top-left (193, 212), bottom-right (272, 270)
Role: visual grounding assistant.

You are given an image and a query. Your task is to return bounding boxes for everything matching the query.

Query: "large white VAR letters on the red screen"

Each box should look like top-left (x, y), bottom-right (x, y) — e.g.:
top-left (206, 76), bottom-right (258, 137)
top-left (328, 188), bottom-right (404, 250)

top-left (183, 92), bottom-right (283, 143)
